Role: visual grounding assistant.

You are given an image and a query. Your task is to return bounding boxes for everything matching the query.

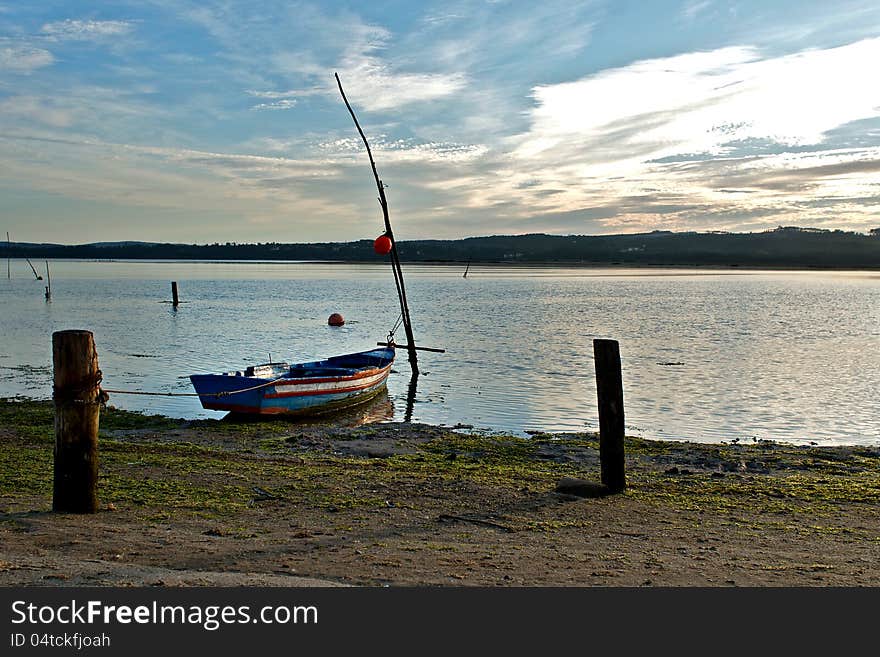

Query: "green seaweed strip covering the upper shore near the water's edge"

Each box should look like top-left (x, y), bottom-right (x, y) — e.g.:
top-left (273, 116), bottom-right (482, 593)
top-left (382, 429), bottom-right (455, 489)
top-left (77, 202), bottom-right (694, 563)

top-left (0, 399), bottom-right (880, 531)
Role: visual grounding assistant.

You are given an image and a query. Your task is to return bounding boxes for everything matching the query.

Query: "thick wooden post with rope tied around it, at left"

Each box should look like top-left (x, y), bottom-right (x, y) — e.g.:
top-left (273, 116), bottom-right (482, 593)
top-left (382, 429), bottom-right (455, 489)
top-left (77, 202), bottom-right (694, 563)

top-left (52, 331), bottom-right (103, 513)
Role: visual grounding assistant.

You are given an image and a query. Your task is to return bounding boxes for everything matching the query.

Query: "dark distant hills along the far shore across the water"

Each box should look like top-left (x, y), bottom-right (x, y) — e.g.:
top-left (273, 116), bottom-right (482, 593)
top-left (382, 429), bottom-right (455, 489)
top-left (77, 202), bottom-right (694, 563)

top-left (0, 227), bottom-right (880, 268)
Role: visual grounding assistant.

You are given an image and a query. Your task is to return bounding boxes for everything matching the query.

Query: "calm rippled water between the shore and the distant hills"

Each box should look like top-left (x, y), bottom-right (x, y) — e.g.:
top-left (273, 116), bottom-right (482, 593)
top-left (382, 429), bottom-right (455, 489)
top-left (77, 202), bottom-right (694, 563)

top-left (0, 260), bottom-right (880, 444)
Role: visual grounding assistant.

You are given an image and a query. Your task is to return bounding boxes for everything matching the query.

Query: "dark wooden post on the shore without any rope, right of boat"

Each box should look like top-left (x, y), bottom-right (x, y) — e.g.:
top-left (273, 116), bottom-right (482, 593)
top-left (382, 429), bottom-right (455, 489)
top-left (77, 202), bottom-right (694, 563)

top-left (593, 340), bottom-right (626, 493)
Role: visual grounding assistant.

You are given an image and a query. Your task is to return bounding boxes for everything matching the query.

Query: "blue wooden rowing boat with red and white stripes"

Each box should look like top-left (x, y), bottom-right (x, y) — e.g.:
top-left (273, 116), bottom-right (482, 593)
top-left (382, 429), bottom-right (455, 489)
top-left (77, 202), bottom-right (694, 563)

top-left (189, 346), bottom-right (394, 415)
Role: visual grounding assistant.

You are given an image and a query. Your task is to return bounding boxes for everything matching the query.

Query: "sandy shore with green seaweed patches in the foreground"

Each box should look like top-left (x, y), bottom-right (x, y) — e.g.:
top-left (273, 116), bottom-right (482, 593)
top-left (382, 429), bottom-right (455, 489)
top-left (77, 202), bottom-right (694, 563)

top-left (0, 400), bottom-right (880, 586)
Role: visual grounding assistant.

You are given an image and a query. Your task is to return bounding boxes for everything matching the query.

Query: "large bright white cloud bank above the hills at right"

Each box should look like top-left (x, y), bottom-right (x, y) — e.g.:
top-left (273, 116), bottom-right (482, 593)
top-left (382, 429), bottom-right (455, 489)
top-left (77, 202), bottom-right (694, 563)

top-left (498, 38), bottom-right (880, 229)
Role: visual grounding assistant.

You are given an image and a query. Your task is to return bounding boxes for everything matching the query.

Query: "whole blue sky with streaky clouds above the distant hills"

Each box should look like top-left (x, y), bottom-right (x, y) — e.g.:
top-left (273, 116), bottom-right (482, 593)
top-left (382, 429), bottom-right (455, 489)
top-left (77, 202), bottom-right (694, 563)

top-left (0, 0), bottom-right (880, 244)
